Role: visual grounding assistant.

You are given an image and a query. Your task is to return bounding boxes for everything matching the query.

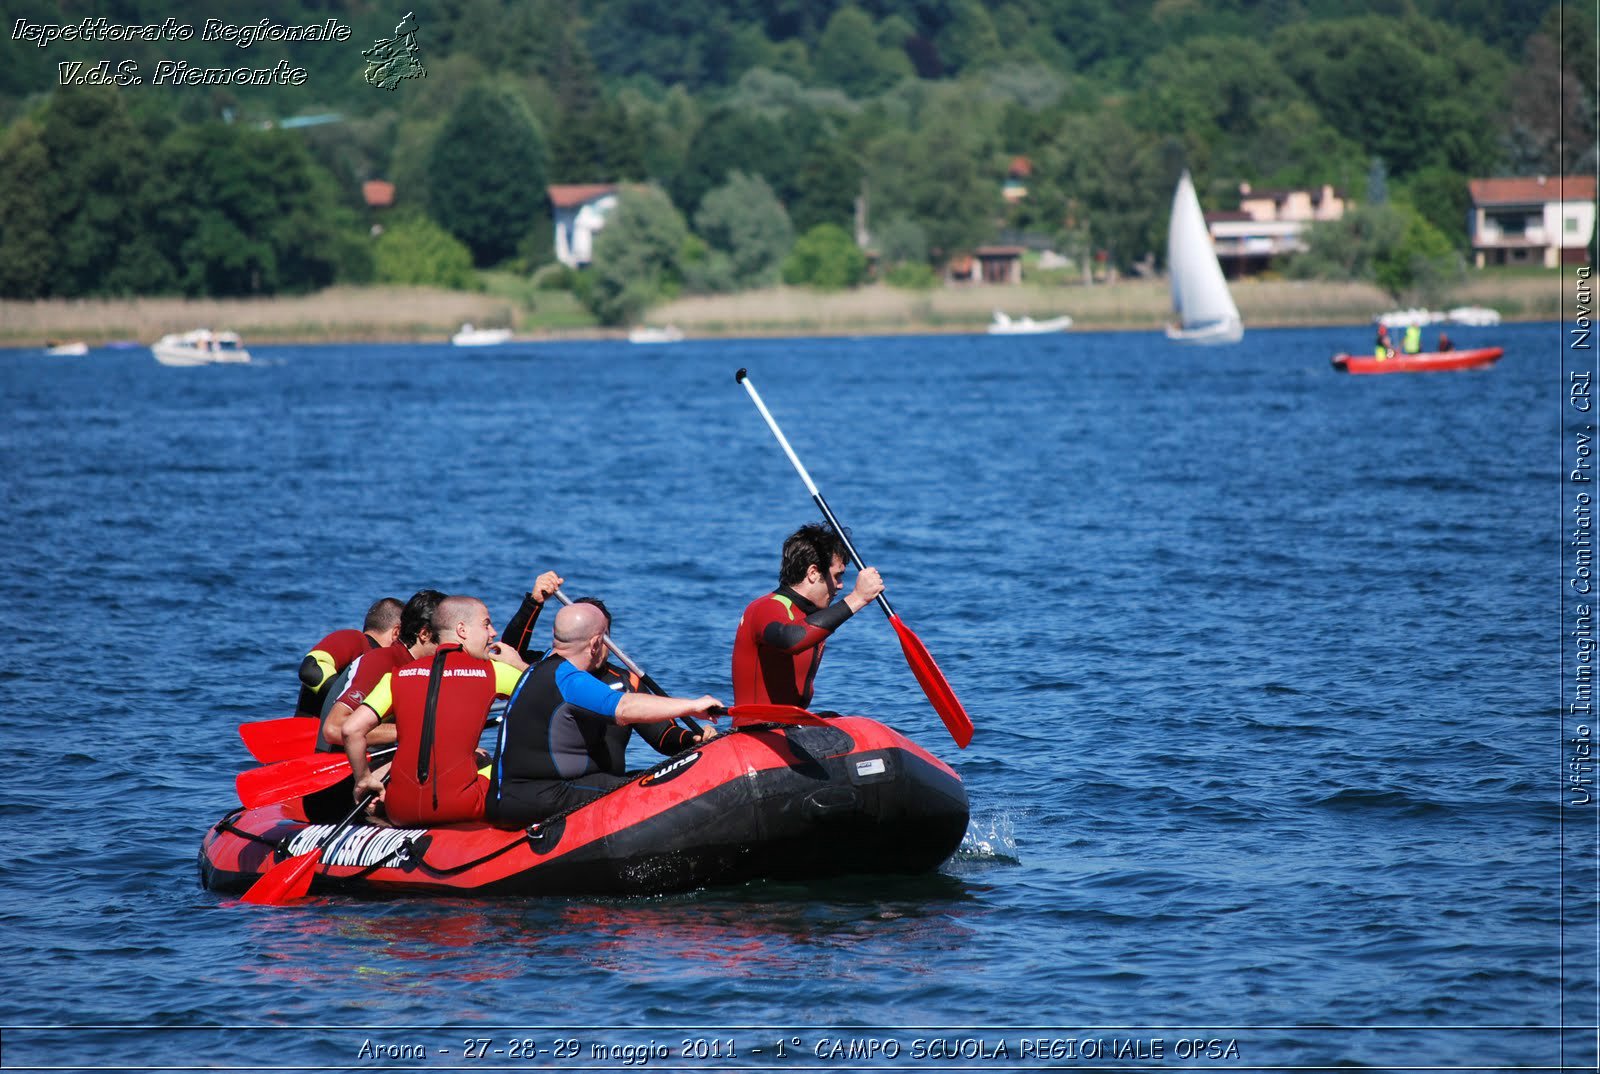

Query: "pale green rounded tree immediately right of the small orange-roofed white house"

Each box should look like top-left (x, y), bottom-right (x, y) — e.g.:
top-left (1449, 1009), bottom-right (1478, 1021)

top-left (586, 187), bottom-right (690, 325)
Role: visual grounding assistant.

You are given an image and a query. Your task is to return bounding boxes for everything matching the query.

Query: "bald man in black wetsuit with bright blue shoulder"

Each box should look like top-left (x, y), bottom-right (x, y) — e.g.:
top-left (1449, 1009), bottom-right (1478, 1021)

top-left (485, 603), bottom-right (722, 828)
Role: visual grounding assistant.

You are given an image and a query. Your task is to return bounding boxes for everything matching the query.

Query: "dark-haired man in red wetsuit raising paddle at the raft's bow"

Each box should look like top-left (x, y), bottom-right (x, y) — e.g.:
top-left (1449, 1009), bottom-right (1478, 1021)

top-left (733, 523), bottom-right (883, 707)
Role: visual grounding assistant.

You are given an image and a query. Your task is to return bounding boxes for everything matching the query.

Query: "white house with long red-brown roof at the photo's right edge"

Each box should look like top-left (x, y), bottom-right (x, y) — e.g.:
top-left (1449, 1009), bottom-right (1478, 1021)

top-left (1467, 176), bottom-right (1595, 269)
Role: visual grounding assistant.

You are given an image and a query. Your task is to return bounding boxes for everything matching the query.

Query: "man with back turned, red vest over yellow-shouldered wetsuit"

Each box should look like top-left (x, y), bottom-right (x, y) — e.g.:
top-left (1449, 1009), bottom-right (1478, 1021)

top-left (344, 597), bottom-right (526, 828)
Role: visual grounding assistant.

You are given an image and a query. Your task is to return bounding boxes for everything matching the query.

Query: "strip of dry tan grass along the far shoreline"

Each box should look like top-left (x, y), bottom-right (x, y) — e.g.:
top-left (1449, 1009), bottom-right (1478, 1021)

top-left (0, 272), bottom-right (1563, 347)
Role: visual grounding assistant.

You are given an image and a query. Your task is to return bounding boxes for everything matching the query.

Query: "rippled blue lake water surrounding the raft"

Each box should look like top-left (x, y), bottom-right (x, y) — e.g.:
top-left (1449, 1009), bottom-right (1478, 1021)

top-left (0, 325), bottom-right (1595, 1071)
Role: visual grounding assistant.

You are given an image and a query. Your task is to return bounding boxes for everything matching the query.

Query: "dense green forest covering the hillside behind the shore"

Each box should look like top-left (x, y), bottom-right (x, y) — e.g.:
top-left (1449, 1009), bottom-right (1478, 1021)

top-left (0, 0), bottom-right (1597, 320)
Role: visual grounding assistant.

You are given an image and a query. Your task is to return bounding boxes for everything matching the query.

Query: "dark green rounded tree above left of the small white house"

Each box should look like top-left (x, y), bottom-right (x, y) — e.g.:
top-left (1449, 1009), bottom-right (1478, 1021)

top-left (427, 85), bottom-right (549, 266)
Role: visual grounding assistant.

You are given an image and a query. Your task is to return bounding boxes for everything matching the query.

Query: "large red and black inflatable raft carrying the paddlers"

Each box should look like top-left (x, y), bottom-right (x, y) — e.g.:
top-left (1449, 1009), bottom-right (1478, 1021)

top-left (200, 715), bottom-right (968, 895)
